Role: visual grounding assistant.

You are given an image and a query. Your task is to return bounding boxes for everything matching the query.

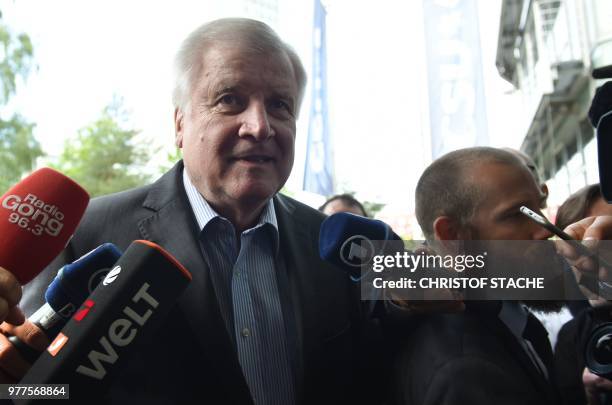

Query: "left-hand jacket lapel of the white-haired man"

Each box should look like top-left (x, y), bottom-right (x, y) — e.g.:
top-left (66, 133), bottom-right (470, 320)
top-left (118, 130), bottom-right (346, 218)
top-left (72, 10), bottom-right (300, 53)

top-left (138, 161), bottom-right (251, 403)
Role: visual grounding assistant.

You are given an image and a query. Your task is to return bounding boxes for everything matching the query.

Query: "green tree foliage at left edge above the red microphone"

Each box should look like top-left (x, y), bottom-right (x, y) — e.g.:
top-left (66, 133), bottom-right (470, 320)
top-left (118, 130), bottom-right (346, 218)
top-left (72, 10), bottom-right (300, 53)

top-left (0, 13), bottom-right (43, 194)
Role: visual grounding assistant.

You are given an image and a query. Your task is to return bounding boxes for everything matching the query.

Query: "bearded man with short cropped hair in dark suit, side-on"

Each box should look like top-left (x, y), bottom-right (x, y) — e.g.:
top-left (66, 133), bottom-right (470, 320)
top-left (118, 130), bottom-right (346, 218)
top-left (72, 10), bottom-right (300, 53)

top-left (396, 148), bottom-right (557, 405)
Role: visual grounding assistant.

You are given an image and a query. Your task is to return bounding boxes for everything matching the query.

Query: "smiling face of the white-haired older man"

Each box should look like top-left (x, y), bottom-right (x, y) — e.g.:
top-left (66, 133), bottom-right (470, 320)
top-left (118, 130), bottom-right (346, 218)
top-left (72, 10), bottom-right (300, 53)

top-left (175, 44), bottom-right (298, 209)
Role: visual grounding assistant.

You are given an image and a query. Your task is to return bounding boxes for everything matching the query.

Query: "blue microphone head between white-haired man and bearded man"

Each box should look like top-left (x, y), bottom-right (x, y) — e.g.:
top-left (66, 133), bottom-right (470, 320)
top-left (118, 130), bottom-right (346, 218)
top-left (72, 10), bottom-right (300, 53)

top-left (319, 212), bottom-right (404, 282)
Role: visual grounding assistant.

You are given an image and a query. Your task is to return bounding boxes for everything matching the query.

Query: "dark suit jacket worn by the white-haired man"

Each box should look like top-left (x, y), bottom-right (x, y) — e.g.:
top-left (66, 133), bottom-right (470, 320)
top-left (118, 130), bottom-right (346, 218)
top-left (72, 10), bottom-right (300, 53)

top-left (22, 162), bottom-right (358, 404)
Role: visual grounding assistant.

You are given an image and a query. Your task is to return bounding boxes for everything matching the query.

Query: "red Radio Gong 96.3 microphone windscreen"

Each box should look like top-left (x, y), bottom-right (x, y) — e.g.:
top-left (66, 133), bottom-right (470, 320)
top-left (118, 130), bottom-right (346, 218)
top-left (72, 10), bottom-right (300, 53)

top-left (0, 168), bottom-right (89, 285)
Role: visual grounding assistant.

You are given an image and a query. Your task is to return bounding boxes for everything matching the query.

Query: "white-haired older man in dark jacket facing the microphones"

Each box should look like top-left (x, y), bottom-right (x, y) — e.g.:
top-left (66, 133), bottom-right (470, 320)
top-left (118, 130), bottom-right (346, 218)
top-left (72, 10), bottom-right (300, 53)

top-left (0, 19), bottom-right (366, 404)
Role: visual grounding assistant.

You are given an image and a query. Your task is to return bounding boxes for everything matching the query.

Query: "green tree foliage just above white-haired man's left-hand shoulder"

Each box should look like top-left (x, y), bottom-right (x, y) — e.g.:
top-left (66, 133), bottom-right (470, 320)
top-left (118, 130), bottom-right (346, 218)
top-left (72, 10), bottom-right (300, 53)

top-left (55, 100), bottom-right (152, 197)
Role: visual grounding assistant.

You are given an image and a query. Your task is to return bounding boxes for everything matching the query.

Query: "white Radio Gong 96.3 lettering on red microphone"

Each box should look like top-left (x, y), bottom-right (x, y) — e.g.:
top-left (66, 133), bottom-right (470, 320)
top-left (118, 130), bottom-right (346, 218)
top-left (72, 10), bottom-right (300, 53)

top-left (2, 194), bottom-right (64, 236)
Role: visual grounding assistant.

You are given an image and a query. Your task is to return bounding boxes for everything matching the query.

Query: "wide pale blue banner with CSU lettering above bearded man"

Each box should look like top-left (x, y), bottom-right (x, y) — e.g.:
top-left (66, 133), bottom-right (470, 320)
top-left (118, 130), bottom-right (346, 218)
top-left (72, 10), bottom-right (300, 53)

top-left (423, 0), bottom-right (489, 159)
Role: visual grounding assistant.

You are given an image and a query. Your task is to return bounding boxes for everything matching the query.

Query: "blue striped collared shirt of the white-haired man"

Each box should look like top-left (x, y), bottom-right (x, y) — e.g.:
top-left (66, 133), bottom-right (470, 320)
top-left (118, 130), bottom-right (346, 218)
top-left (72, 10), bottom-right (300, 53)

top-left (183, 170), bottom-right (296, 404)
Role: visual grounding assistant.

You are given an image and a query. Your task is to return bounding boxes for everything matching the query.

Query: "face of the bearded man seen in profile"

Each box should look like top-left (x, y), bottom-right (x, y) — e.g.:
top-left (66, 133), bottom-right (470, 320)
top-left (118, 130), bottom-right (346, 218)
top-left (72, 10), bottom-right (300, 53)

top-left (467, 163), bottom-right (564, 311)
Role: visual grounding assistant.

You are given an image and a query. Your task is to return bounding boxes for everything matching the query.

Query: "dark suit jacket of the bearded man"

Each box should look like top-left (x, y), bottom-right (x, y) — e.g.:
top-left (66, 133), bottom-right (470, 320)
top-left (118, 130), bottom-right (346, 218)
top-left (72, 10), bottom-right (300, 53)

top-left (395, 310), bottom-right (557, 405)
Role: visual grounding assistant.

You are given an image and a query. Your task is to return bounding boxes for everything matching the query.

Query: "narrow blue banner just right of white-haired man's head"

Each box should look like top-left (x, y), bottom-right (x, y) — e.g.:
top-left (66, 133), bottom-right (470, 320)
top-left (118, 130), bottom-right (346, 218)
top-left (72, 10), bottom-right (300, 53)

top-left (304, 0), bottom-right (334, 196)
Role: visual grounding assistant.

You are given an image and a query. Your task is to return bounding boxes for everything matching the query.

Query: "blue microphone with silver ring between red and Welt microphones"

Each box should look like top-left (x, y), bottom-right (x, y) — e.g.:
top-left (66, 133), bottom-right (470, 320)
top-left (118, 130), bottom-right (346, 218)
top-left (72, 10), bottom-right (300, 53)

top-left (9, 243), bottom-right (121, 362)
